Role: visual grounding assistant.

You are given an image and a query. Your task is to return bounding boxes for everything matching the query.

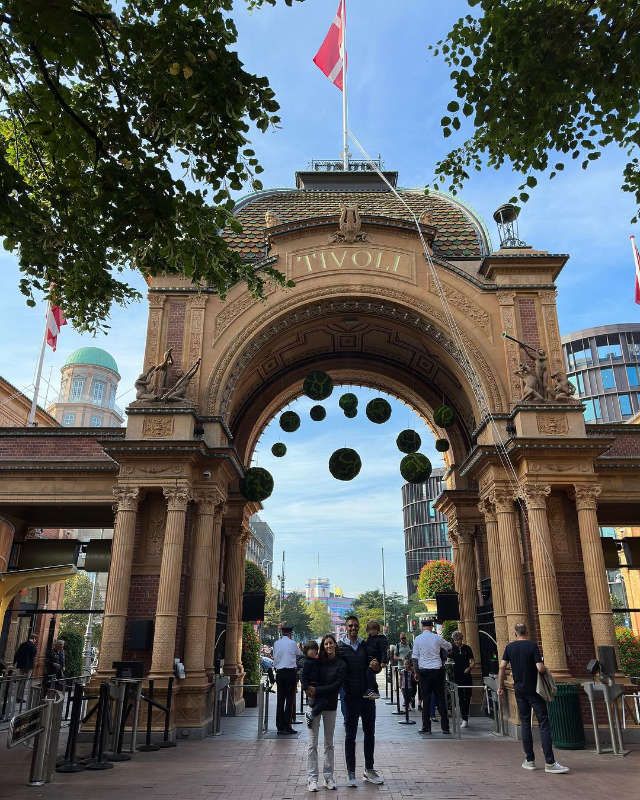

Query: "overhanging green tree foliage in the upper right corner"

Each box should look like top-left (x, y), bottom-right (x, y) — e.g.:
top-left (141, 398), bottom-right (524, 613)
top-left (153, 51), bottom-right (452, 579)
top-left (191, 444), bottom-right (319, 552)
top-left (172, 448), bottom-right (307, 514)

top-left (433, 0), bottom-right (640, 222)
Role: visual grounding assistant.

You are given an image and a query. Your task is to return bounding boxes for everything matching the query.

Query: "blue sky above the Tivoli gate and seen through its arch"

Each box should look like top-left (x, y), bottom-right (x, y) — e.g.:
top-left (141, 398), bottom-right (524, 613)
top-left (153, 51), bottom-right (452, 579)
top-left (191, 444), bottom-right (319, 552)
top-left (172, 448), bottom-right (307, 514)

top-left (0, 0), bottom-right (640, 593)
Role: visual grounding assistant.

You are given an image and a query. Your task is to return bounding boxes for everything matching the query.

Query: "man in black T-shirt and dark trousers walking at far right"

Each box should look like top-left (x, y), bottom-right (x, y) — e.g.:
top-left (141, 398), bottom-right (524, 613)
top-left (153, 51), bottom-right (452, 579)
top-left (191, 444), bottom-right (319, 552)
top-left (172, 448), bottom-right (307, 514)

top-left (498, 623), bottom-right (569, 774)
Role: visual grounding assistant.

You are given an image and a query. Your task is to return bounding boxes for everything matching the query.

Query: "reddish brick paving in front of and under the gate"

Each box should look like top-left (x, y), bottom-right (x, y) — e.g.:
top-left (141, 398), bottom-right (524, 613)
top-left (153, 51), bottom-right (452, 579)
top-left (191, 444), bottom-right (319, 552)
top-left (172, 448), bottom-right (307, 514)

top-left (0, 696), bottom-right (640, 800)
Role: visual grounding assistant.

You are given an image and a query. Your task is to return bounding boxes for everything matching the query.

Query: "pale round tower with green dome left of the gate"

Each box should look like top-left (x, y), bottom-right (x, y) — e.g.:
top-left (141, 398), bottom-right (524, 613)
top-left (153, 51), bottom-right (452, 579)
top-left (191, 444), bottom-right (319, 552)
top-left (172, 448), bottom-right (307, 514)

top-left (47, 347), bottom-right (124, 428)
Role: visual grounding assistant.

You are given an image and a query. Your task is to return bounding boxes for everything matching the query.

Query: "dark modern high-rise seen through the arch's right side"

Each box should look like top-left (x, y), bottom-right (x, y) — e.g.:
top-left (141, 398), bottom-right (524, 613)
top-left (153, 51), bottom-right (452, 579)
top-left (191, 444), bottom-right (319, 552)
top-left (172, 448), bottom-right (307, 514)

top-left (402, 469), bottom-right (451, 597)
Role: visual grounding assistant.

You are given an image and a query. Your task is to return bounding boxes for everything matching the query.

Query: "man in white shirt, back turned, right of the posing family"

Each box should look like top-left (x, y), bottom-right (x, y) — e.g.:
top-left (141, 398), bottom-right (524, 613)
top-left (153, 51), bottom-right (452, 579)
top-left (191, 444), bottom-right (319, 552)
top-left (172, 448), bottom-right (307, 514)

top-left (411, 619), bottom-right (451, 733)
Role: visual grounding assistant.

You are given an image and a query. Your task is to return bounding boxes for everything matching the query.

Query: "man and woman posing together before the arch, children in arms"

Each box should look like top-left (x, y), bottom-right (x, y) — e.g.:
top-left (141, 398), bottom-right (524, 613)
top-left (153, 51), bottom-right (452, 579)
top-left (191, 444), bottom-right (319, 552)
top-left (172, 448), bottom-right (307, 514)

top-left (302, 616), bottom-right (384, 792)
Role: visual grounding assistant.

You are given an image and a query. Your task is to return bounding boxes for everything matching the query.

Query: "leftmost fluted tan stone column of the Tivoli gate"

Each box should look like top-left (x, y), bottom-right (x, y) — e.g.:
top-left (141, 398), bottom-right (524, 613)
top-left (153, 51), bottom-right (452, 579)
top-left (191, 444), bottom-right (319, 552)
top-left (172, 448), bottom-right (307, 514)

top-left (98, 486), bottom-right (139, 675)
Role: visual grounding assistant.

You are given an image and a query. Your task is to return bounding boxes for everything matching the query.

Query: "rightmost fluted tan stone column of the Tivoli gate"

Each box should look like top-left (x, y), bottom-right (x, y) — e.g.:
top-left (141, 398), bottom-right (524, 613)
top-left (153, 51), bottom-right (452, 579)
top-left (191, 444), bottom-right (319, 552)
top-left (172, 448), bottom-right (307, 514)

top-left (575, 484), bottom-right (616, 653)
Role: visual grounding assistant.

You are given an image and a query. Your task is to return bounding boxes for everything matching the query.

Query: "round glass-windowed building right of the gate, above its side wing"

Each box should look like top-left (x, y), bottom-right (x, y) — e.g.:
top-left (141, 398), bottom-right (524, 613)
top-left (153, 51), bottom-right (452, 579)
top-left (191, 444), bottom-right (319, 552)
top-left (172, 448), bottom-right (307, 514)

top-left (562, 323), bottom-right (640, 422)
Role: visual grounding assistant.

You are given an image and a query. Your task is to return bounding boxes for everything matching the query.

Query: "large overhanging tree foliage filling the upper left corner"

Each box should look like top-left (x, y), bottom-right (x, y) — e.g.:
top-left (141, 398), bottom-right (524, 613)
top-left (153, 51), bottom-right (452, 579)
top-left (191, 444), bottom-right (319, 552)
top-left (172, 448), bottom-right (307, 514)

top-left (0, 0), bottom-right (300, 331)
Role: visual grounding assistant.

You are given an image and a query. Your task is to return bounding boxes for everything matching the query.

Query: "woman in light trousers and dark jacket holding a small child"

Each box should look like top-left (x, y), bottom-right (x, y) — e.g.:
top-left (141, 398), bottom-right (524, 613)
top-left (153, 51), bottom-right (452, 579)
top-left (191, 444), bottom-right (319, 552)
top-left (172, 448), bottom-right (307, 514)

top-left (302, 633), bottom-right (346, 792)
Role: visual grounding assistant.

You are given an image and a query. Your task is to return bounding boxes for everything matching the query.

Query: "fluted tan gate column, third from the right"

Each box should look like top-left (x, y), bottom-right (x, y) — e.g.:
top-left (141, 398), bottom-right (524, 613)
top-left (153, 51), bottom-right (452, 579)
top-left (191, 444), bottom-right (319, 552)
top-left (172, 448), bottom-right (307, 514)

top-left (489, 488), bottom-right (528, 636)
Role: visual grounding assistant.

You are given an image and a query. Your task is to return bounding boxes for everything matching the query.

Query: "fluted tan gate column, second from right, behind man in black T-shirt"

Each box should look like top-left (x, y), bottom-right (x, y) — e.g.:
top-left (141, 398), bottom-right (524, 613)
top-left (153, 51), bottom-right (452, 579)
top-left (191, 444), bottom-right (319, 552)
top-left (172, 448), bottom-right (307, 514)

top-left (522, 483), bottom-right (567, 673)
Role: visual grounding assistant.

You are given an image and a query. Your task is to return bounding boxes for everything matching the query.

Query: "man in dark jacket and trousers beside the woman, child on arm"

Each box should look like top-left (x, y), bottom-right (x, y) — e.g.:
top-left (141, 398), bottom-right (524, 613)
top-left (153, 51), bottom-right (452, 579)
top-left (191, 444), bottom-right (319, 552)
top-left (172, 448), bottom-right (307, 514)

top-left (338, 614), bottom-right (384, 786)
